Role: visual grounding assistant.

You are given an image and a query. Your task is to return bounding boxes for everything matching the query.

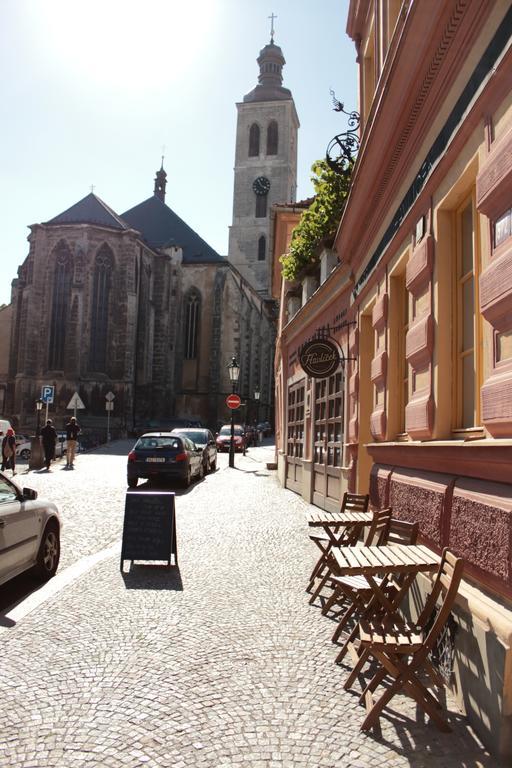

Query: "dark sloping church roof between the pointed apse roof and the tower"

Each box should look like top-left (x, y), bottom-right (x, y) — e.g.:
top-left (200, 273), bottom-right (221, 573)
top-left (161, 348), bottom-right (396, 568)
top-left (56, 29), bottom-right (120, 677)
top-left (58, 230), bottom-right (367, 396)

top-left (122, 195), bottom-right (225, 264)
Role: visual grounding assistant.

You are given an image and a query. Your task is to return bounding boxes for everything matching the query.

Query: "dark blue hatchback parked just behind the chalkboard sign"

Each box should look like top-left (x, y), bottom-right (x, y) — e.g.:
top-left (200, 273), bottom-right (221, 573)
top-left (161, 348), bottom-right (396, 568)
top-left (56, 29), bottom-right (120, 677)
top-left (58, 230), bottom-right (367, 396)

top-left (127, 432), bottom-right (204, 488)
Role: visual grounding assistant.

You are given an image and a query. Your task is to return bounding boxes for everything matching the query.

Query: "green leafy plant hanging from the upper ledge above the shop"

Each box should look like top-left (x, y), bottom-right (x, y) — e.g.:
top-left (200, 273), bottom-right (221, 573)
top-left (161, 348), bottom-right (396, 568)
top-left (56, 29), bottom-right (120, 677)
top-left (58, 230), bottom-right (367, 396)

top-left (280, 160), bottom-right (353, 280)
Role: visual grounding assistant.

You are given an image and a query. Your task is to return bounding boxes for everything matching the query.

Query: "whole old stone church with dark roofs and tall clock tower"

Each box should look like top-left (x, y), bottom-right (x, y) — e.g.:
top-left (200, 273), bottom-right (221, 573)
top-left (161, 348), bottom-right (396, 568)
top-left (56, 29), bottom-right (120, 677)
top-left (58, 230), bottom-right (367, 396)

top-left (4, 33), bottom-right (299, 436)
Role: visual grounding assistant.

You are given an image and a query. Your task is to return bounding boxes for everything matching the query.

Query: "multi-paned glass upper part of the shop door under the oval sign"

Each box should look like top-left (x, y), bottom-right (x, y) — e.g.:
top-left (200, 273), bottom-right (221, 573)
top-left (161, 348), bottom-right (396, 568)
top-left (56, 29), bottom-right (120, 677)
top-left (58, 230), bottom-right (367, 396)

top-left (313, 371), bottom-right (344, 467)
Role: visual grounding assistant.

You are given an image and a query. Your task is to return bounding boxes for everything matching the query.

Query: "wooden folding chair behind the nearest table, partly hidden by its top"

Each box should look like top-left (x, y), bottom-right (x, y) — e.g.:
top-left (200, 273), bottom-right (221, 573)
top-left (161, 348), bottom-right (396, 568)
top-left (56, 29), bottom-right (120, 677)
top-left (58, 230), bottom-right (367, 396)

top-left (328, 518), bottom-right (419, 664)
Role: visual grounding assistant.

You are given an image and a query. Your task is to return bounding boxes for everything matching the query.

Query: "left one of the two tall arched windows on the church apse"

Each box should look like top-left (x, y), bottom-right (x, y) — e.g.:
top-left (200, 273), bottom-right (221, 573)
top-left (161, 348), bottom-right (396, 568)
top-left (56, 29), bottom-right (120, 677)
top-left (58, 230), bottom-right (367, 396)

top-left (48, 240), bottom-right (73, 369)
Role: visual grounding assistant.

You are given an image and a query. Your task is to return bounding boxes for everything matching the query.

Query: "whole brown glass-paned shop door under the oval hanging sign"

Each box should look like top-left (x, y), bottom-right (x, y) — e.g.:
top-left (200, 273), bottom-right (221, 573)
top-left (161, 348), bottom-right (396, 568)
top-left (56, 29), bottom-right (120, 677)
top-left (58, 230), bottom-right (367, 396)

top-left (313, 371), bottom-right (344, 512)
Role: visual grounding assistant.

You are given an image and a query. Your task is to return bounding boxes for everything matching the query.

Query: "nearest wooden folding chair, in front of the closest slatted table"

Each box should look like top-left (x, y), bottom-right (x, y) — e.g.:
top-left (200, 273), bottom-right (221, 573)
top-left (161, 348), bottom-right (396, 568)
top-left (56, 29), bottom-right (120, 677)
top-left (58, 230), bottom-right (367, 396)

top-left (344, 549), bottom-right (464, 731)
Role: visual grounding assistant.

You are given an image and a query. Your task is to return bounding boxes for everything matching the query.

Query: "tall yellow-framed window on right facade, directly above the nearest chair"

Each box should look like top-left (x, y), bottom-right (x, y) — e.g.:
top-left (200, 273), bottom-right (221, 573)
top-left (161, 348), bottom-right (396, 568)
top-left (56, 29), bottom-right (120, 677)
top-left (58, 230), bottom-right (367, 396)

top-left (455, 198), bottom-right (478, 429)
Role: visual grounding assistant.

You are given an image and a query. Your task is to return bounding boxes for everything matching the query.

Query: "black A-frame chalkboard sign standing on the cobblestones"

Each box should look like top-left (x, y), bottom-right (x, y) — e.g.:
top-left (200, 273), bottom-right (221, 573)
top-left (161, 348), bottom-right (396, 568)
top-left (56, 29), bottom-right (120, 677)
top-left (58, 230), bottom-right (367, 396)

top-left (121, 490), bottom-right (178, 570)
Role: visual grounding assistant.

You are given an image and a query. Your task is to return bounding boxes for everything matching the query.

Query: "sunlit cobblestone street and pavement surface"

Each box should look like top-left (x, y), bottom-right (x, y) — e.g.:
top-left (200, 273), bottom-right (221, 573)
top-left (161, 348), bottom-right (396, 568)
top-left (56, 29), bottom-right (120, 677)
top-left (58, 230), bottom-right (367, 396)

top-left (0, 444), bottom-right (497, 768)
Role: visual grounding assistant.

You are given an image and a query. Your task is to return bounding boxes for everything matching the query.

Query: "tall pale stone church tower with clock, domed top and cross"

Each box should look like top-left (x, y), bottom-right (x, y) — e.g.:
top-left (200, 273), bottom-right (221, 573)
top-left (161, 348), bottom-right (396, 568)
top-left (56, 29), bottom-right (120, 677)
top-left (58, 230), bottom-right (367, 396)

top-left (228, 17), bottom-right (299, 297)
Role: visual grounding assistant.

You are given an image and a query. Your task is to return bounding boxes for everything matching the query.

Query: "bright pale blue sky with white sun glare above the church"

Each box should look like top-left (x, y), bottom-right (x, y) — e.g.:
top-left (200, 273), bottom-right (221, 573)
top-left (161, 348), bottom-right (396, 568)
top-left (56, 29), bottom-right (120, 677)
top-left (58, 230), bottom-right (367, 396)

top-left (0, 0), bottom-right (358, 304)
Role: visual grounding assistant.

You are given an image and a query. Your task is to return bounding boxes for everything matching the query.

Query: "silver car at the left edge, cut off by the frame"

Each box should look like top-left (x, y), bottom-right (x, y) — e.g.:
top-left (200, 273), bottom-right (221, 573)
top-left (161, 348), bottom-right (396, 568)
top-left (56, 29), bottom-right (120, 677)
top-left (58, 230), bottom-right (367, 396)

top-left (0, 472), bottom-right (61, 584)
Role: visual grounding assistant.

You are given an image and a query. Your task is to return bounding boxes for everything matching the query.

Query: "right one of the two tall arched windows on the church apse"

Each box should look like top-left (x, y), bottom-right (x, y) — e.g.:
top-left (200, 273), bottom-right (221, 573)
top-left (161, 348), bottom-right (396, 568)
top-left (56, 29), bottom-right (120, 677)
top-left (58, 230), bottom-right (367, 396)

top-left (89, 243), bottom-right (114, 373)
